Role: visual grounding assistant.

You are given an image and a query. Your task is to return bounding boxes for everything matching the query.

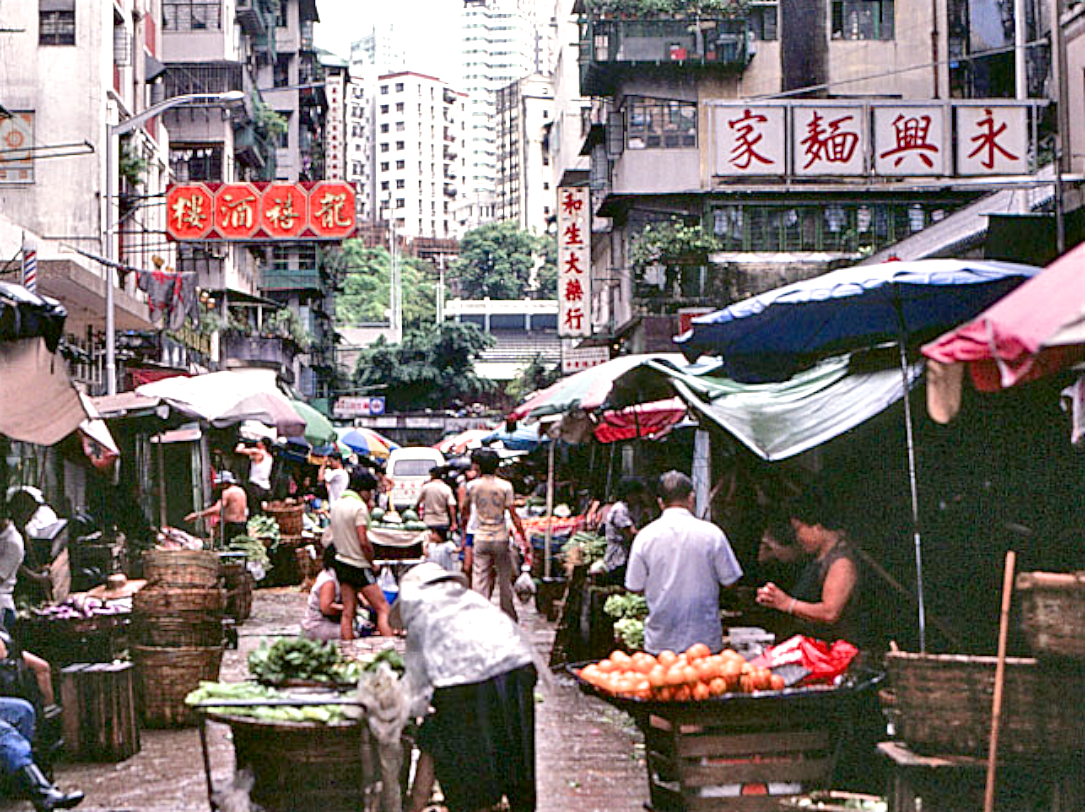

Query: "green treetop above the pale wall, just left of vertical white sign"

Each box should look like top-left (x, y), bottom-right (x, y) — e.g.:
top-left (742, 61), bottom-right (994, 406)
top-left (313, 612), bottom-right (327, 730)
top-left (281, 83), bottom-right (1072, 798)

top-left (451, 220), bottom-right (557, 299)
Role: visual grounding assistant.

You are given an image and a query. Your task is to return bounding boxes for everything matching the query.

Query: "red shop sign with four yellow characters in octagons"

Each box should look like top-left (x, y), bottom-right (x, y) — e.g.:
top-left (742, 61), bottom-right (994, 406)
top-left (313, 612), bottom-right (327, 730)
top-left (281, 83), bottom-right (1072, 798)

top-left (166, 181), bottom-right (356, 241)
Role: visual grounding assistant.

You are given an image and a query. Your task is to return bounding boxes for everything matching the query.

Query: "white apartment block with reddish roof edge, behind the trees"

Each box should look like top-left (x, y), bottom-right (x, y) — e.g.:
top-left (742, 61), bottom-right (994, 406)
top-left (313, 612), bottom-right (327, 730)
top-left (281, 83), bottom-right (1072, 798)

top-left (373, 72), bottom-right (467, 238)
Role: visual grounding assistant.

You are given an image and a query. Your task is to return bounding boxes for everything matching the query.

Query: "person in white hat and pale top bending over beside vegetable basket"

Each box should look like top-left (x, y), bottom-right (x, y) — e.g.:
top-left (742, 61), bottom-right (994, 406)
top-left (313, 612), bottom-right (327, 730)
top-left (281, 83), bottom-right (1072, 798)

top-left (393, 562), bottom-right (537, 812)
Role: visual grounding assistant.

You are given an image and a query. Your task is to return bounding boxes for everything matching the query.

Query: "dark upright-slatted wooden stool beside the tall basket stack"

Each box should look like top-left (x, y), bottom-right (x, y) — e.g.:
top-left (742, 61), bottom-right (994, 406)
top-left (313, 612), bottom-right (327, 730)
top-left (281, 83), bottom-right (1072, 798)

top-left (61, 662), bottom-right (140, 761)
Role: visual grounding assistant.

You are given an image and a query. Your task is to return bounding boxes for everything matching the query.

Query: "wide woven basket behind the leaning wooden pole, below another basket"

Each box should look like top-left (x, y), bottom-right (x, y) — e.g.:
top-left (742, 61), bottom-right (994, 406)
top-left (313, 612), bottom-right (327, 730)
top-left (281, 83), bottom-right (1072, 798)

top-left (886, 651), bottom-right (1085, 756)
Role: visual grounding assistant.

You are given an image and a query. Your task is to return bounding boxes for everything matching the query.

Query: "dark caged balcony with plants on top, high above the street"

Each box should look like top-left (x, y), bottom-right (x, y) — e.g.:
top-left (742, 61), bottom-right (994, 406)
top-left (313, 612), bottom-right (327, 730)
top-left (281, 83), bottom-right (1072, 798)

top-left (580, 15), bottom-right (750, 96)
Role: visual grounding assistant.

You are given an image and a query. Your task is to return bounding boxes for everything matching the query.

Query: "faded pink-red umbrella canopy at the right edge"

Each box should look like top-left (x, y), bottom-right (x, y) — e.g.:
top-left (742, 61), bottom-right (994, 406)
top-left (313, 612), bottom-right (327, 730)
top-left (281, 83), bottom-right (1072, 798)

top-left (923, 243), bottom-right (1085, 392)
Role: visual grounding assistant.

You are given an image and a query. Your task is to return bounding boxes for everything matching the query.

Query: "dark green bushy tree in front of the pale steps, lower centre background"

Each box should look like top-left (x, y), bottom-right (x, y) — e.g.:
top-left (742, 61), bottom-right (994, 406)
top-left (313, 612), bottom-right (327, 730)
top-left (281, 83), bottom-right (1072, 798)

top-left (354, 321), bottom-right (494, 411)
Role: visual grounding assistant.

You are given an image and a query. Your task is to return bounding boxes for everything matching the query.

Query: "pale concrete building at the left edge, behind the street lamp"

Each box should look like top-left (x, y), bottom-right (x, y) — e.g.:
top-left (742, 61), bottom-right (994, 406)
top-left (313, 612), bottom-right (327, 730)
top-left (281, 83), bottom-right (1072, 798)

top-left (0, 0), bottom-right (160, 392)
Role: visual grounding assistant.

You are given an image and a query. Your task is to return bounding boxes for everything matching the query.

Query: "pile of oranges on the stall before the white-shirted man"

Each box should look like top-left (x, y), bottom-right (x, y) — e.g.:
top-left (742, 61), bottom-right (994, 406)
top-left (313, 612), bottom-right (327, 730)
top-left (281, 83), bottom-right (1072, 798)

top-left (577, 643), bottom-right (783, 702)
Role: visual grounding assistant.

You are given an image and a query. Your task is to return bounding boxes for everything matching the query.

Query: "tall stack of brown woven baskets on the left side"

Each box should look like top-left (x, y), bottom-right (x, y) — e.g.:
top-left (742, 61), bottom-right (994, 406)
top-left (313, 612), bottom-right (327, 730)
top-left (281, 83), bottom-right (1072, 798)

top-left (132, 549), bottom-right (227, 727)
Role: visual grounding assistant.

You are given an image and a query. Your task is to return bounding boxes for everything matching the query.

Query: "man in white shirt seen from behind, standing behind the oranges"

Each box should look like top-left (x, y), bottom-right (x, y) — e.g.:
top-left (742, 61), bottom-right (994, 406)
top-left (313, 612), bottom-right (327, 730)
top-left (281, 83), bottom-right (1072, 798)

top-left (625, 471), bottom-right (742, 655)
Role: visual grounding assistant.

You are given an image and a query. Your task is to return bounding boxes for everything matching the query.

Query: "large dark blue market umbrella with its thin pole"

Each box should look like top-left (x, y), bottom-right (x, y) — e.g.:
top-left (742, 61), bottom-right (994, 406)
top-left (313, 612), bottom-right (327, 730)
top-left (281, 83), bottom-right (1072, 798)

top-left (675, 259), bottom-right (1041, 650)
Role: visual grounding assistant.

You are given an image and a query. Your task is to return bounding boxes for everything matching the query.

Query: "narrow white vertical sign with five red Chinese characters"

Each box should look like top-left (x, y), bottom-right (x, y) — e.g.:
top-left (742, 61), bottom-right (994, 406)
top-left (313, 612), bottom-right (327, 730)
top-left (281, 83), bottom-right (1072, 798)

top-left (558, 186), bottom-right (591, 339)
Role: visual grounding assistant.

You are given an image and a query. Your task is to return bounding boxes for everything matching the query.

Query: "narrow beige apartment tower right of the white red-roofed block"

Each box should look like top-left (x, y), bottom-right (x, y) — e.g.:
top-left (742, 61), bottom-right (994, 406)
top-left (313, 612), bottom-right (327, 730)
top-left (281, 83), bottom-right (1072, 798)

top-left (495, 74), bottom-right (553, 234)
